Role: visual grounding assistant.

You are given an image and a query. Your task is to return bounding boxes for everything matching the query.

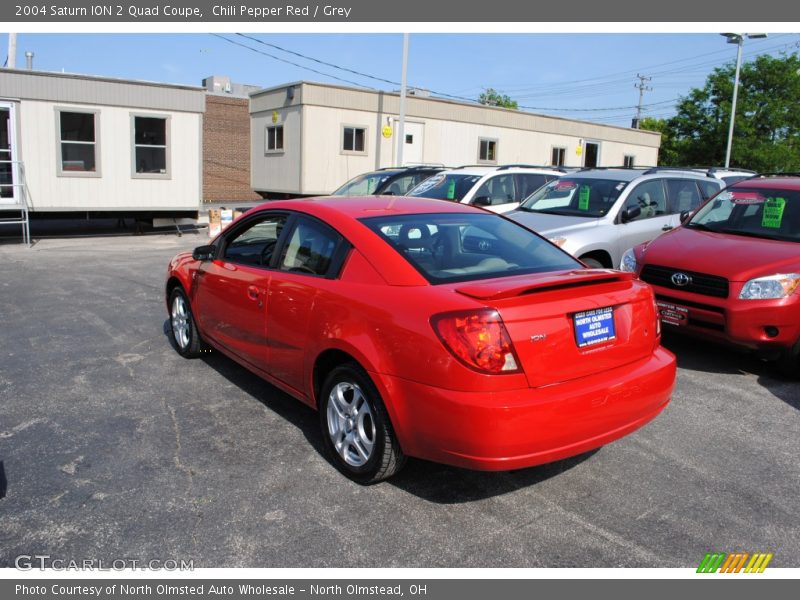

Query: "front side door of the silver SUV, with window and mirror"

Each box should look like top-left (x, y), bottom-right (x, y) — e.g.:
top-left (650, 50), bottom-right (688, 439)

top-left (614, 177), bottom-right (673, 255)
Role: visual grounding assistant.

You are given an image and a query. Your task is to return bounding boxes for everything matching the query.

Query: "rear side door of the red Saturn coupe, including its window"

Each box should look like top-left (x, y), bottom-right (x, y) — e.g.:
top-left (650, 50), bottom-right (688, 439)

top-left (267, 216), bottom-right (349, 393)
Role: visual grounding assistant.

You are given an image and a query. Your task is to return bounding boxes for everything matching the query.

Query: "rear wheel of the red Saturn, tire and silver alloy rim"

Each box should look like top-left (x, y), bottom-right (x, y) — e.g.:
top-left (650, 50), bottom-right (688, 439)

top-left (319, 363), bottom-right (405, 484)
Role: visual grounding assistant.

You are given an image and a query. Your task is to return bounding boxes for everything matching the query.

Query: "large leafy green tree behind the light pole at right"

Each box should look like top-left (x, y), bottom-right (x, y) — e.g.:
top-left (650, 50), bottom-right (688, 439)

top-left (650, 55), bottom-right (800, 172)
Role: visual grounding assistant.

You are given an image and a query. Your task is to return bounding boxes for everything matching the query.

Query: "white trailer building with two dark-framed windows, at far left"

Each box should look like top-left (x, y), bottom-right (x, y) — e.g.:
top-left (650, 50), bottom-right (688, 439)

top-left (0, 69), bottom-right (205, 223)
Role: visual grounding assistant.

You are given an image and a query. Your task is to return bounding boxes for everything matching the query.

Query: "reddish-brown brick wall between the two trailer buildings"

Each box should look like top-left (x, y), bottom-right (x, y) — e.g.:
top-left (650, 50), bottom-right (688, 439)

top-left (203, 94), bottom-right (261, 202)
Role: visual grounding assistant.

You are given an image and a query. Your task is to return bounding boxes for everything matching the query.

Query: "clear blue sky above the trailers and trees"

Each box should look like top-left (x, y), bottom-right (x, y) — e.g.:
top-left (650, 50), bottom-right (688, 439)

top-left (0, 32), bottom-right (800, 127)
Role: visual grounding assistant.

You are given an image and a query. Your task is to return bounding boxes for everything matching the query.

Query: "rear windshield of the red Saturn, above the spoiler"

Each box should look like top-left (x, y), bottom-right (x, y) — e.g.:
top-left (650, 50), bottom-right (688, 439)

top-left (361, 213), bottom-right (583, 284)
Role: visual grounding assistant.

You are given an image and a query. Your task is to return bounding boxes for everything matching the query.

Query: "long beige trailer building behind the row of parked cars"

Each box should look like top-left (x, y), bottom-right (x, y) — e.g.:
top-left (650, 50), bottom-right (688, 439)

top-left (250, 81), bottom-right (661, 198)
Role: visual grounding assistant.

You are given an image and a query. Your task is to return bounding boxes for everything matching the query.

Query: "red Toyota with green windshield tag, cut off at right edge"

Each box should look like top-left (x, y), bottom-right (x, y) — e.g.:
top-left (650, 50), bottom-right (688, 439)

top-left (622, 171), bottom-right (800, 375)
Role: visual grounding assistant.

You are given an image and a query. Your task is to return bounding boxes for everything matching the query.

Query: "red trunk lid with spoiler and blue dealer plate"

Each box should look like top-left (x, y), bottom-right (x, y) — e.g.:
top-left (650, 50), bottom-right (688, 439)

top-left (455, 269), bottom-right (657, 387)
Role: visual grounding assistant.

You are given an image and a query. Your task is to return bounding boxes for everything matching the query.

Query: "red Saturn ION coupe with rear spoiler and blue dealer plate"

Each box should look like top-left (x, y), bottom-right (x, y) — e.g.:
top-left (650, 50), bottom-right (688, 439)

top-left (166, 197), bottom-right (675, 483)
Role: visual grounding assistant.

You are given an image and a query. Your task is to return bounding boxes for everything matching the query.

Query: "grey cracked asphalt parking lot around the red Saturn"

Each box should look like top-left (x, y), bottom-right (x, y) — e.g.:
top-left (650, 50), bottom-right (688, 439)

top-left (0, 234), bottom-right (800, 567)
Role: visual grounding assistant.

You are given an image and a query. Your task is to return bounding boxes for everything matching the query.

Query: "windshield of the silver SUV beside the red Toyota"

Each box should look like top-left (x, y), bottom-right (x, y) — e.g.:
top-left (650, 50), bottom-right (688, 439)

top-left (519, 177), bottom-right (628, 219)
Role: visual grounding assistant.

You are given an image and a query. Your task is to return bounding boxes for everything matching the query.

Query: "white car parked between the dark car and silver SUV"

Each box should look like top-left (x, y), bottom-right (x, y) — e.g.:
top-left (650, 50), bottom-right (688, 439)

top-left (408, 165), bottom-right (566, 213)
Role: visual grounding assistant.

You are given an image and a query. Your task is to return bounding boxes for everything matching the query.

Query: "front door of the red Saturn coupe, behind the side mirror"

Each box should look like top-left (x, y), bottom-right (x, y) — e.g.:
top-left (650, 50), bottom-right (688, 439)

top-left (193, 212), bottom-right (289, 369)
